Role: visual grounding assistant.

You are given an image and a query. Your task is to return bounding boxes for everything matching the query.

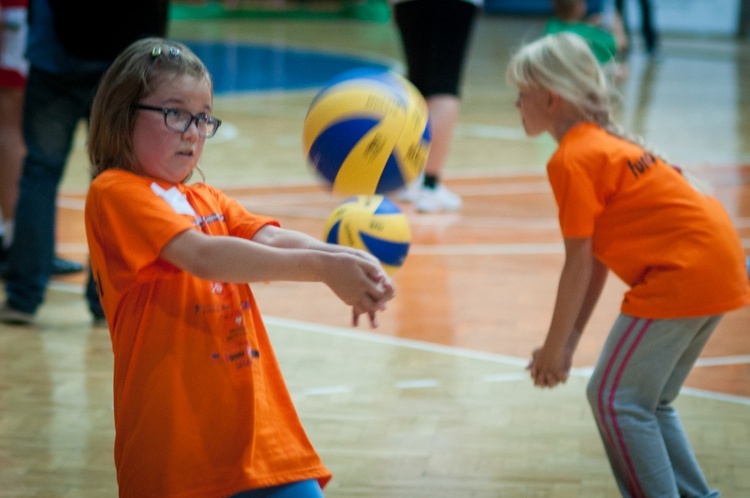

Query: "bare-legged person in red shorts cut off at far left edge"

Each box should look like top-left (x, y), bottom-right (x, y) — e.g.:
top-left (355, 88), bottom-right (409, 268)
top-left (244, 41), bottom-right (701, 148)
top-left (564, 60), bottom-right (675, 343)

top-left (0, 0), bottom-right (29, 263)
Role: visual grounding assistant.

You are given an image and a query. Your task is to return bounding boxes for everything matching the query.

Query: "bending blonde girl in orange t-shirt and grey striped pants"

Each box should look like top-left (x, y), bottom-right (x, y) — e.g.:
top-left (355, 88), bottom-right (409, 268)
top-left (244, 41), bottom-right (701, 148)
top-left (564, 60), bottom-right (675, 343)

top-left (506, 33), bottom-right (750, 498)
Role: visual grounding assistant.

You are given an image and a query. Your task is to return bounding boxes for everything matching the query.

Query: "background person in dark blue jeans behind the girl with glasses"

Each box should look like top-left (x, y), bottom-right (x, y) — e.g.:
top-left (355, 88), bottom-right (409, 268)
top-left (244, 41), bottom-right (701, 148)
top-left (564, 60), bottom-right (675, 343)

top-left (0, 0), bottom-right (168, 324)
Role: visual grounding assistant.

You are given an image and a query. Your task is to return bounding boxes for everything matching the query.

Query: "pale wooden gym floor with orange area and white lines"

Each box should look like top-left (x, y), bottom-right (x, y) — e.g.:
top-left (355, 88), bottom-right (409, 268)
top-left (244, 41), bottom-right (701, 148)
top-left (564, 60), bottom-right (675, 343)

top-left (0, 8), bottom-right (750, 498)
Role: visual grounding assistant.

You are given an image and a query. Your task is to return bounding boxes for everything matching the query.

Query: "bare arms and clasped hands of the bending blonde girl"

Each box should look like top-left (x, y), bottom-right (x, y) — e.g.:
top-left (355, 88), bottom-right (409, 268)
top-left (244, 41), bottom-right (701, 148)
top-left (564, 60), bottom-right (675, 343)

top-left (529, 238), bottom-right (607, 387)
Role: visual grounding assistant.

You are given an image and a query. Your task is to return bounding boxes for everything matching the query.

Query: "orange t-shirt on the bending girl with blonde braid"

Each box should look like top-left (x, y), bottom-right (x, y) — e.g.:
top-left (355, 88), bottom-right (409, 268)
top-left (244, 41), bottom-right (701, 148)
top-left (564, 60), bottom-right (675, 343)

top-left (547, 123), bottom-right (750, 319)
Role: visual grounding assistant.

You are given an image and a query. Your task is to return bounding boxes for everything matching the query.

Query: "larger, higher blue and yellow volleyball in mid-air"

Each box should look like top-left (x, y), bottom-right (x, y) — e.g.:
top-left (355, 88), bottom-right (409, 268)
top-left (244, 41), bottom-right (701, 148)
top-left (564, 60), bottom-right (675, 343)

top-left (302, 69), bottom-right (430, 196)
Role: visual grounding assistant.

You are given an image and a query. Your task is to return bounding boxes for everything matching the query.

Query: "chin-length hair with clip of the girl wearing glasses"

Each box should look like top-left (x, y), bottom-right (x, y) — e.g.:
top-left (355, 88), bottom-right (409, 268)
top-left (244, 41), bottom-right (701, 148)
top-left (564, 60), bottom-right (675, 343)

top-left (88, 38), bottom-right (213, 177)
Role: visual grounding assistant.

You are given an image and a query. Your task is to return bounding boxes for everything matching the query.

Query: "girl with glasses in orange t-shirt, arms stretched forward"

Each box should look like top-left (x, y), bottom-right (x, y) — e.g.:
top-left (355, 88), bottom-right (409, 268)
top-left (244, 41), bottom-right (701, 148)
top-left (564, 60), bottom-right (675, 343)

top-left (85, 38), bottom-right (394, 498)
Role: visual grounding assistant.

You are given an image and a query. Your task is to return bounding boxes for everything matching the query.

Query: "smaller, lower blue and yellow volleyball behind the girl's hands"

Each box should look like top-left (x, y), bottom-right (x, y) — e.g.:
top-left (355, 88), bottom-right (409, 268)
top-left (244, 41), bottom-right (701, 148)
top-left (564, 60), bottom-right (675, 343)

top-left (323, 195), bottom-right (411, 274)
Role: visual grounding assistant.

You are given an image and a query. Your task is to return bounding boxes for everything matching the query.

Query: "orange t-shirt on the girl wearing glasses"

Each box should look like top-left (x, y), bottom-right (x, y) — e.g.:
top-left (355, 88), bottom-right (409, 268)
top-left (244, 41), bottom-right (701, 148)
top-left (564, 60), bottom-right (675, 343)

top-left (86, 169), bottom-right (331, 498)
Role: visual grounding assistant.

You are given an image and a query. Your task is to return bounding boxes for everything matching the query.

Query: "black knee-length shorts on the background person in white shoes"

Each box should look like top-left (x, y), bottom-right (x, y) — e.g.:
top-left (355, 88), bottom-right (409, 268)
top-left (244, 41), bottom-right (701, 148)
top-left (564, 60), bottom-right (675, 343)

top-left (393, 0), bottom-right (478, 97)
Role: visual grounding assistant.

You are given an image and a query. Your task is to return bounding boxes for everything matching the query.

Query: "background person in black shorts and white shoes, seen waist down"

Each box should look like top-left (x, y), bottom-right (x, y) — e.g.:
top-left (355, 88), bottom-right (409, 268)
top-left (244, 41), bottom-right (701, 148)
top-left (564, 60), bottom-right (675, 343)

top-left (391, 0), bottom-right (482, 213)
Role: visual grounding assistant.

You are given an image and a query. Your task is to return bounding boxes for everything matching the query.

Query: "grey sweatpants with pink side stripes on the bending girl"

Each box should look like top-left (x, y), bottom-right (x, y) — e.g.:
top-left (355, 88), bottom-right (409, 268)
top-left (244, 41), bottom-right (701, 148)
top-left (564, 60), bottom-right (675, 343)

top-left (587, 315), bottom-right (718, 498)
